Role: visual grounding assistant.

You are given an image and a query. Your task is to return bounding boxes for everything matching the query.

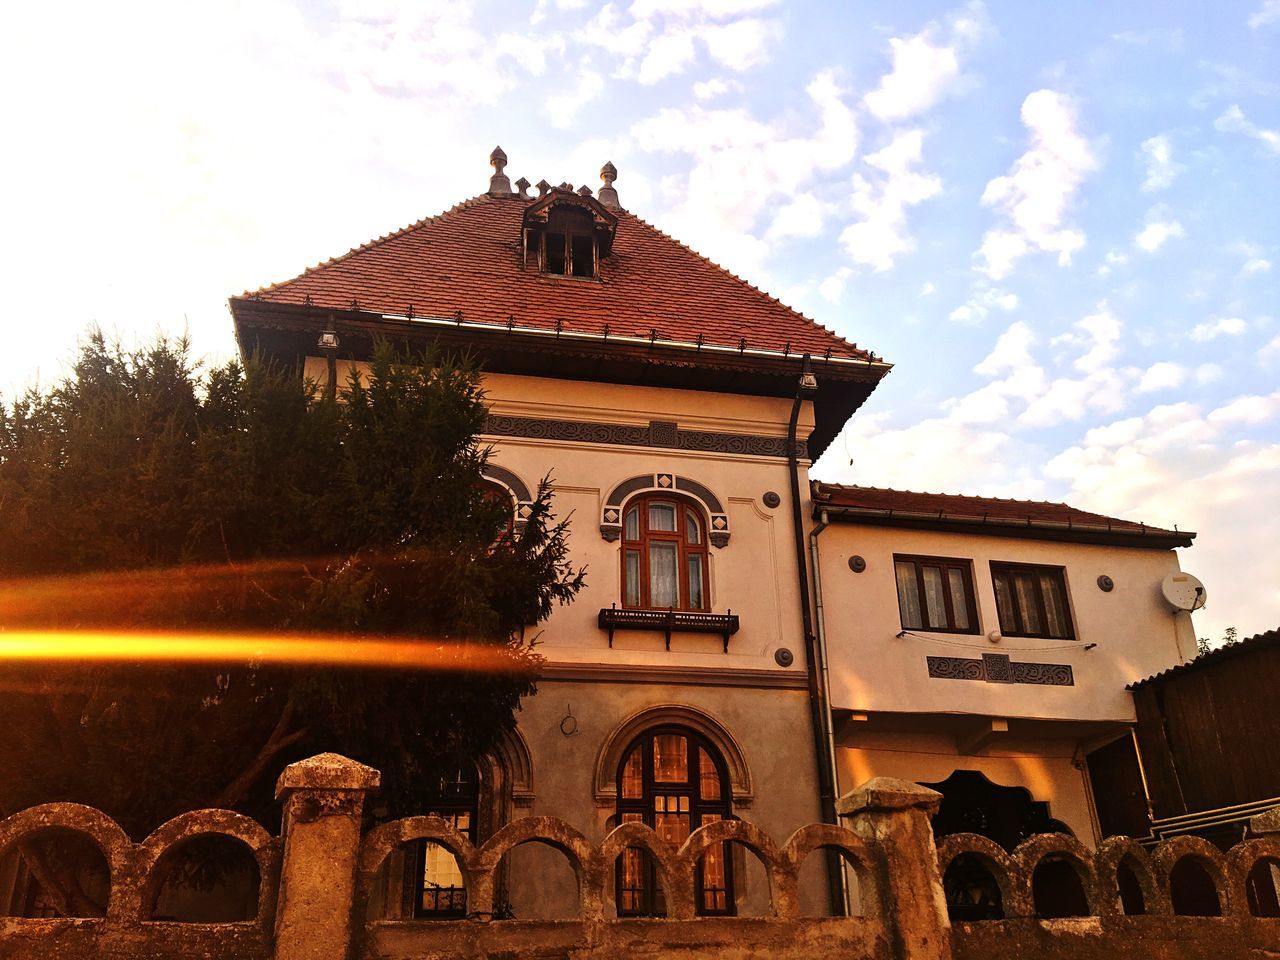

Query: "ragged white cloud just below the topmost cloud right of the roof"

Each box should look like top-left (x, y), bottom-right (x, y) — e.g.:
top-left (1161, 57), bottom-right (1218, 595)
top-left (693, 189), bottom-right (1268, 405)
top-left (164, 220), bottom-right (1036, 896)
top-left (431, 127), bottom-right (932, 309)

top-left (840, 129), bottom-right (942, 273)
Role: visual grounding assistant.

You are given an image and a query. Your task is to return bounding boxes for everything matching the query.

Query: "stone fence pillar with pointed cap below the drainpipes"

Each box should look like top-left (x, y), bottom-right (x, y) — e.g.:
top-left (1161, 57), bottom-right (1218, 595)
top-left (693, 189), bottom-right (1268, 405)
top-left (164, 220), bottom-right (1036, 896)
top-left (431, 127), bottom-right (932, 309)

top-left (836, 777), bottom-right (951, 960)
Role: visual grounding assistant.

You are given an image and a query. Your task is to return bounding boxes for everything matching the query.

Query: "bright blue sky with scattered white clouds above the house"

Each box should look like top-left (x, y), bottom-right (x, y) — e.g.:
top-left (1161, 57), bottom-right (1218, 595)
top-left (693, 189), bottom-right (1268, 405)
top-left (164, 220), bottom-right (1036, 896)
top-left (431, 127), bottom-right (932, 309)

top-left (0, 0), bottom-right (1280, 647)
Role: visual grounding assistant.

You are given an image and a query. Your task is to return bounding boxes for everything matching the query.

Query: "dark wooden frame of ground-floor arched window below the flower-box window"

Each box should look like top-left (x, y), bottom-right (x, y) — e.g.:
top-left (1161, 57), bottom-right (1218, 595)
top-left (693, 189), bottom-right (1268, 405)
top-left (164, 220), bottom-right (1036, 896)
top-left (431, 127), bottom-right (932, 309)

top-left (614, 724), bottom-right (737, 916)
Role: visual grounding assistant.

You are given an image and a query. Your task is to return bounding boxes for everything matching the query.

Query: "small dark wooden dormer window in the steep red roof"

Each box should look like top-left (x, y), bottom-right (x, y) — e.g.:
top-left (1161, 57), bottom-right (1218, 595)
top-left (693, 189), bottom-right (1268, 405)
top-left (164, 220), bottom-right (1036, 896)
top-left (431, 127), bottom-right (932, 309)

top-left (524, 187), bottom-right (617, 278)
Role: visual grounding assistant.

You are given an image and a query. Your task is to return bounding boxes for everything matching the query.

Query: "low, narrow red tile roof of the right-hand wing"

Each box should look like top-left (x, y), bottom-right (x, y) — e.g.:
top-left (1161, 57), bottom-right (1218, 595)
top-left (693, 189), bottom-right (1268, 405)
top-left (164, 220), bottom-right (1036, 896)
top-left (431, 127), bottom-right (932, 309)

top-left (813, 483), bottom-right (1196, 547)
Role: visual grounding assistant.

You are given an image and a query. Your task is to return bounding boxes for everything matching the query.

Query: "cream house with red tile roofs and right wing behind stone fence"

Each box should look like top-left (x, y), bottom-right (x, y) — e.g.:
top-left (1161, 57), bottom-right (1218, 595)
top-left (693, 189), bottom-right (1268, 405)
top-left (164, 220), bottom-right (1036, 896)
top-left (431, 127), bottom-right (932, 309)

top-left (222, 150), bottom-right (1194, 916)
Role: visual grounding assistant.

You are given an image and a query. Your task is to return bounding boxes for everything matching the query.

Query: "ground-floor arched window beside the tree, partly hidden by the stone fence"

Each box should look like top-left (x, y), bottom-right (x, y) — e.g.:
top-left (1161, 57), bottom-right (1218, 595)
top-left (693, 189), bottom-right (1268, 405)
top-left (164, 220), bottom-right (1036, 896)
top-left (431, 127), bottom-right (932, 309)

top-left (410, 765), bottom-right (480, 919)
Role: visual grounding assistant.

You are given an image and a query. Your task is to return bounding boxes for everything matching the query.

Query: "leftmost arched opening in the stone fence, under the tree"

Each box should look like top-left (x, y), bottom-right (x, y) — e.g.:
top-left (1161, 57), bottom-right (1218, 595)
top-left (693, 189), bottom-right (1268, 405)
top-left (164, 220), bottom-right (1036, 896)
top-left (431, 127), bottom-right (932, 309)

top-left (3, 829), bottom-right (111, 918)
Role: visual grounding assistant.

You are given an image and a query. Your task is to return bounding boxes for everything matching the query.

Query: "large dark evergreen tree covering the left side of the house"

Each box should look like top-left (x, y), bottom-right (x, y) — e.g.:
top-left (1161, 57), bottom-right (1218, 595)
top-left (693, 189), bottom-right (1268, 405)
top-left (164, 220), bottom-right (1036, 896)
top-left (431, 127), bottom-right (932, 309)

top-left (0, 332), bottom-right (582, 837)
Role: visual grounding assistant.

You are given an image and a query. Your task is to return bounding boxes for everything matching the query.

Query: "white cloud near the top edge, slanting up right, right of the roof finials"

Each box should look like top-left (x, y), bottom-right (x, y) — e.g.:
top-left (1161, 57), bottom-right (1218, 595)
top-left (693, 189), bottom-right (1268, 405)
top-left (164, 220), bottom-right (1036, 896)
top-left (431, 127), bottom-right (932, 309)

top-left (863, 3), bottom-right (986, 120)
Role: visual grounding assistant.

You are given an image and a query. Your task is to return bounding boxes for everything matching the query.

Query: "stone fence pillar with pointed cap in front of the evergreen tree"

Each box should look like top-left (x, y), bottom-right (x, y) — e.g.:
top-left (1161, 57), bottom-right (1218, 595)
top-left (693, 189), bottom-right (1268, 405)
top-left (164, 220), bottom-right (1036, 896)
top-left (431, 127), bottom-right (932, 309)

top-left (275, 754), bottom-right (381, 960)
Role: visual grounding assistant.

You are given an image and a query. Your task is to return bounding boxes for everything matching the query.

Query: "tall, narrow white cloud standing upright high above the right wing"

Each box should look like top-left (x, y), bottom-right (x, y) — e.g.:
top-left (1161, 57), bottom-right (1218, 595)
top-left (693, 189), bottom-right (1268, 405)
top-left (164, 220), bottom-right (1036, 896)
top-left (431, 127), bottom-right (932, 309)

top-left (978, 90), bottom-right (1097, 280)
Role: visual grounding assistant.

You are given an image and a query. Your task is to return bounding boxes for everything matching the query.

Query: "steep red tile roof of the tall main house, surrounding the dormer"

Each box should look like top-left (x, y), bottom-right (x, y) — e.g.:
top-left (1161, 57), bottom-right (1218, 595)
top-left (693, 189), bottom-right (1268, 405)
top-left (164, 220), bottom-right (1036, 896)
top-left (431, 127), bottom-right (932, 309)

top-left (236, 195), bottom-right (872, 360)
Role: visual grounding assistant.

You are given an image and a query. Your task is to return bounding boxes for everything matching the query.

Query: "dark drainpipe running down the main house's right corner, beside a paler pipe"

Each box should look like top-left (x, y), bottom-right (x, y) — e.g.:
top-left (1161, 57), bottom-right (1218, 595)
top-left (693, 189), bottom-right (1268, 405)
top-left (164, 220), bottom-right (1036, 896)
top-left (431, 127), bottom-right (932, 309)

top-left (787, 353), bottom-right (845, 916)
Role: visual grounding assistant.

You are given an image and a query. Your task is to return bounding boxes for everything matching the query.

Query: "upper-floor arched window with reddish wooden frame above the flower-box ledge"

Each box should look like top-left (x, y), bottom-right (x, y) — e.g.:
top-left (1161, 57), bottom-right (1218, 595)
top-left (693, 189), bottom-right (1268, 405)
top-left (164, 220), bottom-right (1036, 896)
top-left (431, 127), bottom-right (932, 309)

top-left (622, 493), bottom-right (710, 611)
